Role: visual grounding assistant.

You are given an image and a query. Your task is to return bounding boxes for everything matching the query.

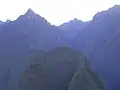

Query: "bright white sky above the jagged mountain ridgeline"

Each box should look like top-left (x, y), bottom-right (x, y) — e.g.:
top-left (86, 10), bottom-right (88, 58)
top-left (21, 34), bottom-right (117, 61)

top-left (0, 0), bottom-right (120, 25)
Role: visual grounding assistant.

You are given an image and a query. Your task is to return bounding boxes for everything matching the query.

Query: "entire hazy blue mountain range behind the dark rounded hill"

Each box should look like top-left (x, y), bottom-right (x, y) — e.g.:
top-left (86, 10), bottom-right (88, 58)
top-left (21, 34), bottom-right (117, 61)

top-left (0, 5), bottom-right (120, 90)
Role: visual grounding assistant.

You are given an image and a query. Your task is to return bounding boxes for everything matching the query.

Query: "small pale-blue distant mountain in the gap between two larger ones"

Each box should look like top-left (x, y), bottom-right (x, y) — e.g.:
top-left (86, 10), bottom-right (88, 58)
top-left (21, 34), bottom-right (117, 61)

top-left (59, 18), bottom-right (88, 39)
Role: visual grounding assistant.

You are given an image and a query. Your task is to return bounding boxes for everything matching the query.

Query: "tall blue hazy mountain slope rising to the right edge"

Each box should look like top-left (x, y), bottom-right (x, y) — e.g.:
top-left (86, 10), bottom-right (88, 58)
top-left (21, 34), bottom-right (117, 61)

top-left (72, 5), bottom-right (120, 90)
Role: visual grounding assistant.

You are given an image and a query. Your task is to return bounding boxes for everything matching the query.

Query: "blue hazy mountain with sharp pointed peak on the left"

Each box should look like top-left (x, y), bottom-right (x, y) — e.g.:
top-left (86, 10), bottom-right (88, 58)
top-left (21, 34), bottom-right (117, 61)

top-left (0, 9), bottom-right (64, 90)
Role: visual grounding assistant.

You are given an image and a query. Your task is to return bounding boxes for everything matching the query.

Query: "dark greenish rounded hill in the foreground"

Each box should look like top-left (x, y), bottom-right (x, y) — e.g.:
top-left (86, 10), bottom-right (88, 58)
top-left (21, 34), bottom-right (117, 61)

top-left (19, 47), bottom-right (105, 90)
